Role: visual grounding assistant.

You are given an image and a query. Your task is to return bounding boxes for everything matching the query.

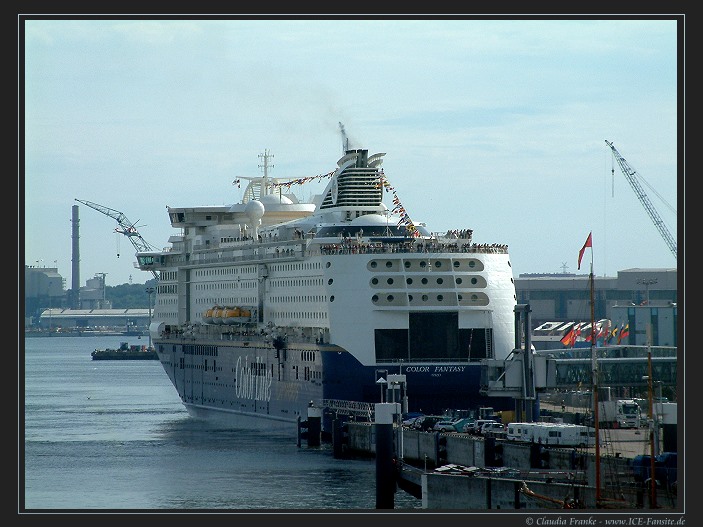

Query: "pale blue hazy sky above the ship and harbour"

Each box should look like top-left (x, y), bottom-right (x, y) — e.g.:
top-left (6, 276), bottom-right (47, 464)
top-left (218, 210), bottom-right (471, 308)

top-left (18, 16), bottom-right (684, 288)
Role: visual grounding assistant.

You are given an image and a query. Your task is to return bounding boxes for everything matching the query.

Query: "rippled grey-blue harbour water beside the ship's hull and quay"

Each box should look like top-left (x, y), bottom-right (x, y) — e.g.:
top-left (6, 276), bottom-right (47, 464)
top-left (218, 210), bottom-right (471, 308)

top-left (18, 337), bottom-right (421, 513)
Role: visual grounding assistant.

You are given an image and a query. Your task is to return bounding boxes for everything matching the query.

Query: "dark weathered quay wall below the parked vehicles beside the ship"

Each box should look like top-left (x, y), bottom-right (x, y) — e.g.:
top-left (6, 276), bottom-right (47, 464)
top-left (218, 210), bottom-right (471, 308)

top-left (346, 422), bottom-right (678, 510)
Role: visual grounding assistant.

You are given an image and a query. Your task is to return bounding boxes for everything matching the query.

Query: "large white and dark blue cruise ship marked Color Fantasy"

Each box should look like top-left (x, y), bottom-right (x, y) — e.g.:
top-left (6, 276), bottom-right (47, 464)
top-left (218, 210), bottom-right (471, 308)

top-left (135, 149), bottom-right (516, 434)
